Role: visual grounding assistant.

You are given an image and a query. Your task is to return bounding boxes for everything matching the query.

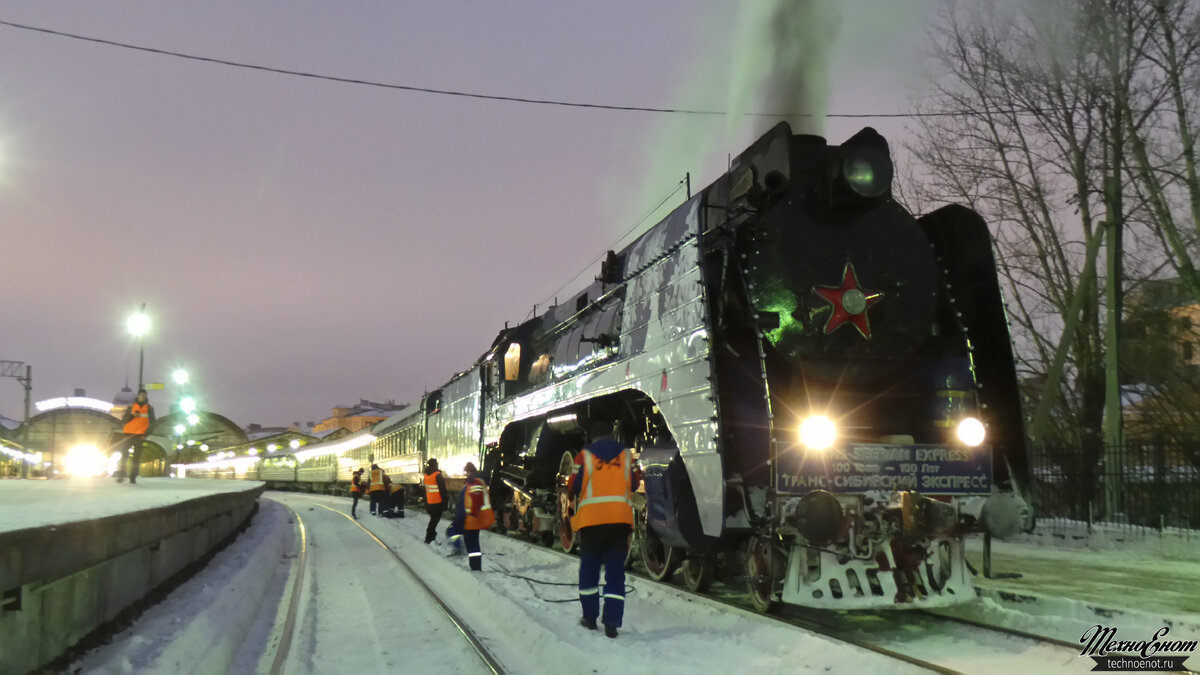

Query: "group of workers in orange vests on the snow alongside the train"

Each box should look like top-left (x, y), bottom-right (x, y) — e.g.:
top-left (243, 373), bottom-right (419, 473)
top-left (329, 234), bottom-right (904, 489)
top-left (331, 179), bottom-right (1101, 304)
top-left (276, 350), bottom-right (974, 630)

top-left (350, 422), bottom-right (638, 638)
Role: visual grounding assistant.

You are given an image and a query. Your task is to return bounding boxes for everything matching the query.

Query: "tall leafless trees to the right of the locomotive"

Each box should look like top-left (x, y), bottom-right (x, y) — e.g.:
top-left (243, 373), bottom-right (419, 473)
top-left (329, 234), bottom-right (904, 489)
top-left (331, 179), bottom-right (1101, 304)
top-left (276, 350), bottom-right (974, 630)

top-left (910, 0), bottom-right (1200, 511)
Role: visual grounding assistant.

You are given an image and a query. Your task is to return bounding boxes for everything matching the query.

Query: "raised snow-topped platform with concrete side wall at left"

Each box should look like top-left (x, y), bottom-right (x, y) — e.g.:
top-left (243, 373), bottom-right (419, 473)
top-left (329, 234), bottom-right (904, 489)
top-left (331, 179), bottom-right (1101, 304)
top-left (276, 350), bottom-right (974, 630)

top-left (0, 478), bottom-right (264, 673)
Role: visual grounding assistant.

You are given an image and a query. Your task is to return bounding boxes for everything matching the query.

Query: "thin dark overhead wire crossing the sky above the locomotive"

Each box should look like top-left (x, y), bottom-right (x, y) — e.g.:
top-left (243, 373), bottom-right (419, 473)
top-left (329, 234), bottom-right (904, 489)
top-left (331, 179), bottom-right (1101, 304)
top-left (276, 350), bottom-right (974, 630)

top-left (0, 19), bottom-right (958, 118)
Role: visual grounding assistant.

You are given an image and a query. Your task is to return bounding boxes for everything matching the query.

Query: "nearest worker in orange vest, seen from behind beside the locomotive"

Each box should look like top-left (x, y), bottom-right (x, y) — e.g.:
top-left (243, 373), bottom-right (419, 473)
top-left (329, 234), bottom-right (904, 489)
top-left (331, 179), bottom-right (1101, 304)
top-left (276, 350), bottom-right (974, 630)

top-left (568, 420), bottom-right (637, 638)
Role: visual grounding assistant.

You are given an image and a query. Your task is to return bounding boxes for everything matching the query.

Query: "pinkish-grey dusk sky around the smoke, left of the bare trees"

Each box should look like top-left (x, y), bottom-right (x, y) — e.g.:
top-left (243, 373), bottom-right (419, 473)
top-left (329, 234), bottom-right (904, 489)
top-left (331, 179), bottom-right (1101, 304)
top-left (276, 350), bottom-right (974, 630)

top-left (0, 0), bottom-right (931, 425)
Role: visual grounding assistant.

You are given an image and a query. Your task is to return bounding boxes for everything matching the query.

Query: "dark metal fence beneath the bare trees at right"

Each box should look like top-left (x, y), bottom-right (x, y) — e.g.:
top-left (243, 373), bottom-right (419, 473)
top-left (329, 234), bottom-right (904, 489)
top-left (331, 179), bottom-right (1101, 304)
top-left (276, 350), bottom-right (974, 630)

top-left (1030, 441), bottom-right (1200, 532)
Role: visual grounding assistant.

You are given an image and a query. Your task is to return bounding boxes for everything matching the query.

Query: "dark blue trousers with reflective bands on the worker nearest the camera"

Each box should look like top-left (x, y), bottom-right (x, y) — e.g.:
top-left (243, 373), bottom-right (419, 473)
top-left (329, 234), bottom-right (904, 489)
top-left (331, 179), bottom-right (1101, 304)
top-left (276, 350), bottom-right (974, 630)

top-left (578, 524), bottom-right (630, 628)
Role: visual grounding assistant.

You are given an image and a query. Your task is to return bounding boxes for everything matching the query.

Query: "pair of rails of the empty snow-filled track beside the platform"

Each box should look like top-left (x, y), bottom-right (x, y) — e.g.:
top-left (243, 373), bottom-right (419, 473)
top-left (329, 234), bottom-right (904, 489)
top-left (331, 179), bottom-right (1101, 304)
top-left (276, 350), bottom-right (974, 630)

top-left (270, 492), bottom-right (505, 675)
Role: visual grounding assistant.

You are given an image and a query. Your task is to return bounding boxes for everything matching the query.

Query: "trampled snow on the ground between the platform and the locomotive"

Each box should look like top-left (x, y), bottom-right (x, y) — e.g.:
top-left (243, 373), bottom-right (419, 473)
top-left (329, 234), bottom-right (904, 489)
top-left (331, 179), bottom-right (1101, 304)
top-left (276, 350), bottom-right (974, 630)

top-left (63, 492), bottom-right (917, 674)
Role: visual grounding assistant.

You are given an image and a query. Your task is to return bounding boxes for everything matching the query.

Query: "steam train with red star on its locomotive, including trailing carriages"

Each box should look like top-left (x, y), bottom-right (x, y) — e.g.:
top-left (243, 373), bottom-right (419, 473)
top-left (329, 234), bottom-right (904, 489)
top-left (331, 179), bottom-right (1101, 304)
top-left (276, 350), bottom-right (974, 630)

top-left (182, 124), bottom-right (1032, 611)
